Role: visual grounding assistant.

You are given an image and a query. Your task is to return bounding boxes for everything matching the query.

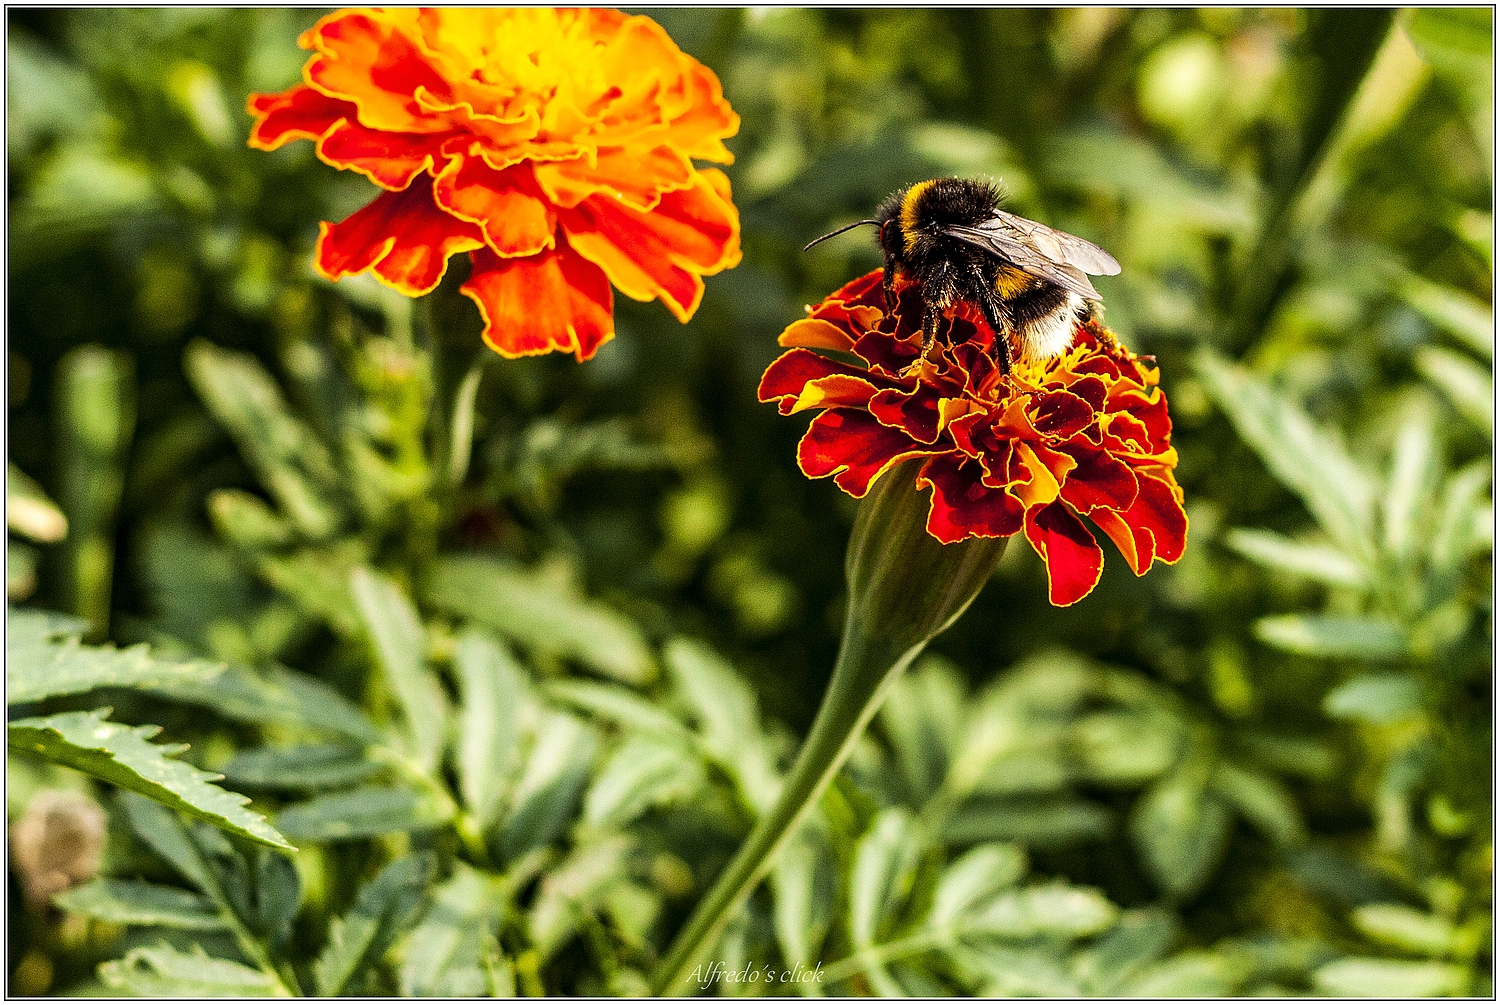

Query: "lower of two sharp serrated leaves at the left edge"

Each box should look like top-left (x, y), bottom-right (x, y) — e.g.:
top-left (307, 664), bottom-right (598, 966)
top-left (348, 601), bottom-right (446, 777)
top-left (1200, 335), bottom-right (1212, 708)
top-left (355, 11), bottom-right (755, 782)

top-left (9, 710), bottom-right (296, 851)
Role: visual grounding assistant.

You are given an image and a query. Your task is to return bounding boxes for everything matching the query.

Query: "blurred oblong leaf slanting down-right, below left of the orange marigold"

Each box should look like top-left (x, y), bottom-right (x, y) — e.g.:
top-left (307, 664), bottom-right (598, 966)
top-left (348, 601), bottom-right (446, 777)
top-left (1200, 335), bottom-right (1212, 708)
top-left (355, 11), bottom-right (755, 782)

top-left (183, 339), bottom-right (341, 540)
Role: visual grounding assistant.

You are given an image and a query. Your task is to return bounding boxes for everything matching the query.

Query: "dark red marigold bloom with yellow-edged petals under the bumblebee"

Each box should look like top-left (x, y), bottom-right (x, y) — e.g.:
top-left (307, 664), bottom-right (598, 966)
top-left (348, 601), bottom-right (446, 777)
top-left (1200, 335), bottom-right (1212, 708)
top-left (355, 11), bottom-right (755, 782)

top-left (761, 270), bottom-right (1188, 606)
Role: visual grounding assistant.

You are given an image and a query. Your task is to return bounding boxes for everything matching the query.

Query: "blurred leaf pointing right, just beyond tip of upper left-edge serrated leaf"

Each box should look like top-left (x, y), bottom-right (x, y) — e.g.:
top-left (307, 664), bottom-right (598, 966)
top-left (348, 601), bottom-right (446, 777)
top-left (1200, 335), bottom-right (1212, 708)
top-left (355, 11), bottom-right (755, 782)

top-left (147, 666), bottom-right (384, 744)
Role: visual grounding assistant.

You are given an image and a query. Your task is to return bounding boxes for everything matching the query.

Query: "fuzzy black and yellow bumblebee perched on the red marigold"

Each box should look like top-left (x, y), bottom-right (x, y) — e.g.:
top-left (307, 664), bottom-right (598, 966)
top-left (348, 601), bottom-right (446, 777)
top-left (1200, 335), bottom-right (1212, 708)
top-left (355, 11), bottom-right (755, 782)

top-left (803, 179), bottom-right (1121, 372)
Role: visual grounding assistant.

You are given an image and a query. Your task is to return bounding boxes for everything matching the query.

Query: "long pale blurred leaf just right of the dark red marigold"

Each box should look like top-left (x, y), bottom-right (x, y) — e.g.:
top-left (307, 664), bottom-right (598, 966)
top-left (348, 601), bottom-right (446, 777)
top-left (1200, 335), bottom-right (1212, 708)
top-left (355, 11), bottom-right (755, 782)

top-left (1196, 351), bottom-right (1376, 561)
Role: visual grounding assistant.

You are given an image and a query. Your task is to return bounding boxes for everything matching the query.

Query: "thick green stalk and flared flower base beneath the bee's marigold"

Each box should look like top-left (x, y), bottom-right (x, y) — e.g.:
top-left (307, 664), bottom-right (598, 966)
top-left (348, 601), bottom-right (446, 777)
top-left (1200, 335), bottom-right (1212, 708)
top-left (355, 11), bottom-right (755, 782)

top-left (651, 459), bottom-right (1010, 995)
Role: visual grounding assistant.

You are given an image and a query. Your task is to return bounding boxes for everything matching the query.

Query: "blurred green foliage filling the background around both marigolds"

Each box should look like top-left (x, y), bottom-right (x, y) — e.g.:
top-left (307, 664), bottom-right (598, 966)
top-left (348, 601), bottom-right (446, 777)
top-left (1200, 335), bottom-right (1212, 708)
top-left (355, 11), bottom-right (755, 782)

top-left (6, 9), bottom-right (1494, 996)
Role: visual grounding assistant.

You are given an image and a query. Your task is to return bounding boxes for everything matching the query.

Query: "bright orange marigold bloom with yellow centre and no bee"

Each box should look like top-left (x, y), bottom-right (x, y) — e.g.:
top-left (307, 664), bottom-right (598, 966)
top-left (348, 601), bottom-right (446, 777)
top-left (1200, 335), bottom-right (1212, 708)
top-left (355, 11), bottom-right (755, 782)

top-left (249, 8), bottom-right (740, 360)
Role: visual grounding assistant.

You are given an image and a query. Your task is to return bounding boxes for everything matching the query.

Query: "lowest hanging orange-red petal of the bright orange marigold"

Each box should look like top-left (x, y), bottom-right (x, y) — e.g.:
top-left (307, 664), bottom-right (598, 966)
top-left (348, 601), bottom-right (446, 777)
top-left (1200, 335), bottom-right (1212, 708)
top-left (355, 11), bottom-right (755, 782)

top-left (461, 248), bottom-right (615, 362)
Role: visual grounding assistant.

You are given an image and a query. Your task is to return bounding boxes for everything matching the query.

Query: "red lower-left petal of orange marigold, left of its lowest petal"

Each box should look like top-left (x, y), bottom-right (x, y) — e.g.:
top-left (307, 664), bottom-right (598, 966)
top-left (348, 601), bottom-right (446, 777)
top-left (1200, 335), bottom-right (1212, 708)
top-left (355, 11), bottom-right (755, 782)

top-left (314, 176), bottom-right (483, 297)
